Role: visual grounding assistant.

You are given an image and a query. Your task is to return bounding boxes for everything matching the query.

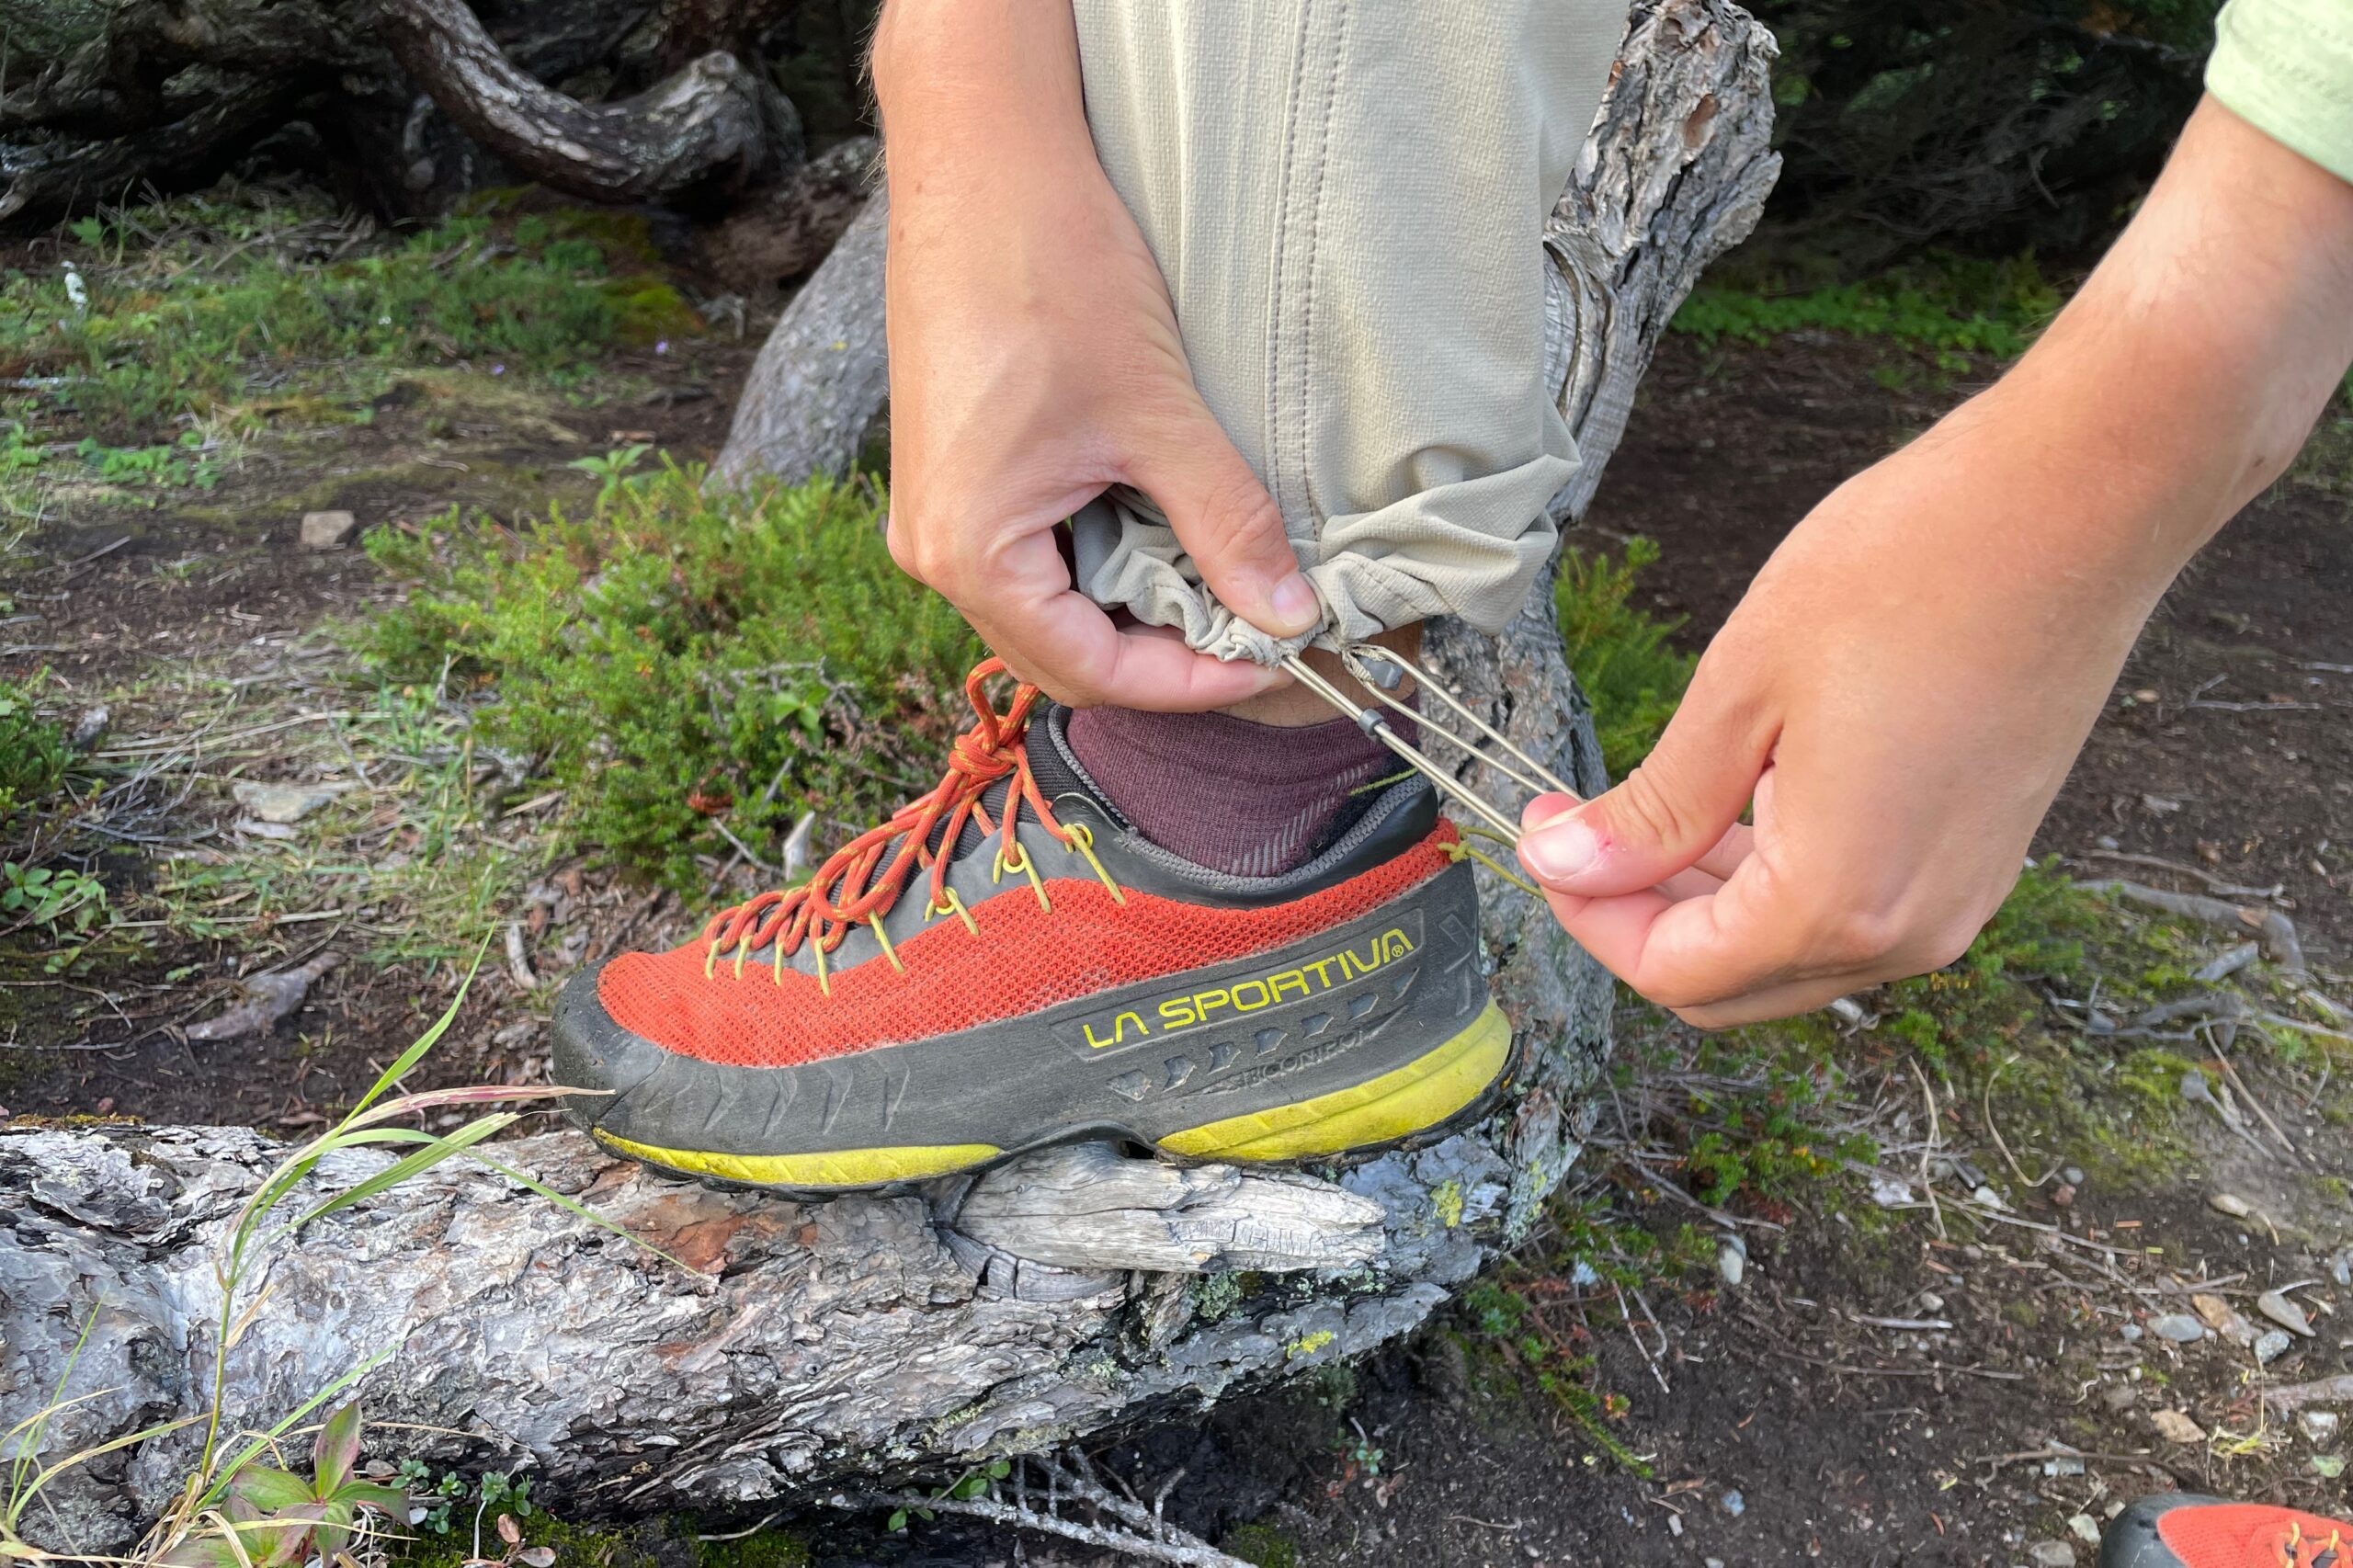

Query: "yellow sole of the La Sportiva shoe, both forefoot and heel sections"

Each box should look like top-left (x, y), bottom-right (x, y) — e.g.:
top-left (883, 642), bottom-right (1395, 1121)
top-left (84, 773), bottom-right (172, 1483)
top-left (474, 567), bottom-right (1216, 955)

top-left (596, 1001), bottom-right (1511, 1191)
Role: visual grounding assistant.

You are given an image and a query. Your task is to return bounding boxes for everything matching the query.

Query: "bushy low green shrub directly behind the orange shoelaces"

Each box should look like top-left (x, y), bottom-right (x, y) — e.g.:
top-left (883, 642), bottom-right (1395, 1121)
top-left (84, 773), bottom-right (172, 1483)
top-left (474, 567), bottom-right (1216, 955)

top-left (356, 464), bottom-right (983, 890)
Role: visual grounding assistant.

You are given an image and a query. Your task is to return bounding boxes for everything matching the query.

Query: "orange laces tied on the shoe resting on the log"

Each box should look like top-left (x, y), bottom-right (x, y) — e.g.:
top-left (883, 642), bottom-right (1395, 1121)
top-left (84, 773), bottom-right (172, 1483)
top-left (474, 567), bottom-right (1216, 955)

top-left (703, 659), bottom-right (1096, 982)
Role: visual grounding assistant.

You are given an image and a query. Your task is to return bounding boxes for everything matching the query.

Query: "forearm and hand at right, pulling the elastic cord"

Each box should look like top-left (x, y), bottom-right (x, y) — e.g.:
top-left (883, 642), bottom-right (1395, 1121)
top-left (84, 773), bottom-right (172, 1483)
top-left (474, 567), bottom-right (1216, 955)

top-left (1520, 99), bottom-right (2353, 1024)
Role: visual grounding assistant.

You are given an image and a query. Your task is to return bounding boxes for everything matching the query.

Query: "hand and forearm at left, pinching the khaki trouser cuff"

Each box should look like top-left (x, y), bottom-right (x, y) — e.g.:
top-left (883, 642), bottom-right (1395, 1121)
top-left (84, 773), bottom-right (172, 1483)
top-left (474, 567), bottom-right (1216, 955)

top-left (873, 0), bottom-right (1318, 709)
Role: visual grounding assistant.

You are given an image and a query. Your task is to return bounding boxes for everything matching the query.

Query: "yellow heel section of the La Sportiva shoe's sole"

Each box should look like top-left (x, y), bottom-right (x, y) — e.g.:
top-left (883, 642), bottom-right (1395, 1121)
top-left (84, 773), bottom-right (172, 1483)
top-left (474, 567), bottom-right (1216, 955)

top-left (1160, 1003), bottom-right (1511, 1161)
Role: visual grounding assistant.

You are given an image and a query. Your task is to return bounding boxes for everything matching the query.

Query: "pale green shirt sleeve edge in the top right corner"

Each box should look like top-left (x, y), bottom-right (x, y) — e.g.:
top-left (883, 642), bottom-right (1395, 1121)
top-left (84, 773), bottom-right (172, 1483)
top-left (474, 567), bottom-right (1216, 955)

top-left (2207, 0), bottom-right (2353, 179)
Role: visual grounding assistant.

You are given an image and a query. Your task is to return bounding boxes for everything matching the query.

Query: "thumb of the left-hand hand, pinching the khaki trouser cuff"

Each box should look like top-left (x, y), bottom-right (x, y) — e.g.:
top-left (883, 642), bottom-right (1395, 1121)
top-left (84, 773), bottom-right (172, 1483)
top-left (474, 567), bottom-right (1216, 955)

top-left (1127, 389), bottom-right (1323, 638)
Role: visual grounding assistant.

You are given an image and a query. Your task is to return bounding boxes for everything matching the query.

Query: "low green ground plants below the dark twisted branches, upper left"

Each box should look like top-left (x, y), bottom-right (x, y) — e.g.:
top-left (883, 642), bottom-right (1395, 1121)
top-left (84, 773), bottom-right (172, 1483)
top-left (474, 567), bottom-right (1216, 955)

top-left (0, 198), bottom-right (701, 445)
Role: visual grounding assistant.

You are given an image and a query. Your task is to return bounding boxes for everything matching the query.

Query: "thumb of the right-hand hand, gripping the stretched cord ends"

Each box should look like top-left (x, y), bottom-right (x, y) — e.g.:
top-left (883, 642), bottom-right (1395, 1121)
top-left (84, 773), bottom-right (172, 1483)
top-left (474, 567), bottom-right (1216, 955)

top-left (1520, 692), bottom-right (1772, 897)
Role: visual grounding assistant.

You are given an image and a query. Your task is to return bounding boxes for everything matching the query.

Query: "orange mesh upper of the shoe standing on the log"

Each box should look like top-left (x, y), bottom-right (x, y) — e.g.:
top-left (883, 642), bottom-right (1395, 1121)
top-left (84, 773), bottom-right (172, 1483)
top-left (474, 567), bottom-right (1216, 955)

top-left (597, 822), bottom-right (1457, 1066)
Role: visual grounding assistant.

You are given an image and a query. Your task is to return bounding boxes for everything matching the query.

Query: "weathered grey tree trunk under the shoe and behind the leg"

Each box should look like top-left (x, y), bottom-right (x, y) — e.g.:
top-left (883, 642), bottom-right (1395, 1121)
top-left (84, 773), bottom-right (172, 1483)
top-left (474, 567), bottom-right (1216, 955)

top-left (0, 0), bottom-right (1774, 1550)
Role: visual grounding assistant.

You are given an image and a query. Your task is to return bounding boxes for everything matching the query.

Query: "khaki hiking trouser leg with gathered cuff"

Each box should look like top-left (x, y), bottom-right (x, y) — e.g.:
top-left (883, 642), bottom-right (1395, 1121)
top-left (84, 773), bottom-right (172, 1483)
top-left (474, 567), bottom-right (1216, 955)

top-left (1073, 0), bottom-right (1626, 664)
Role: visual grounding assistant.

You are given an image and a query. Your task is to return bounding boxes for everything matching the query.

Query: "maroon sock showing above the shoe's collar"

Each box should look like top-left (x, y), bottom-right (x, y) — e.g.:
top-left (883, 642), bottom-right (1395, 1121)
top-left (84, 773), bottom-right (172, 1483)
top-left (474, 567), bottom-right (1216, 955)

top-left (1068, 709), bottom-right (1409, 876)
